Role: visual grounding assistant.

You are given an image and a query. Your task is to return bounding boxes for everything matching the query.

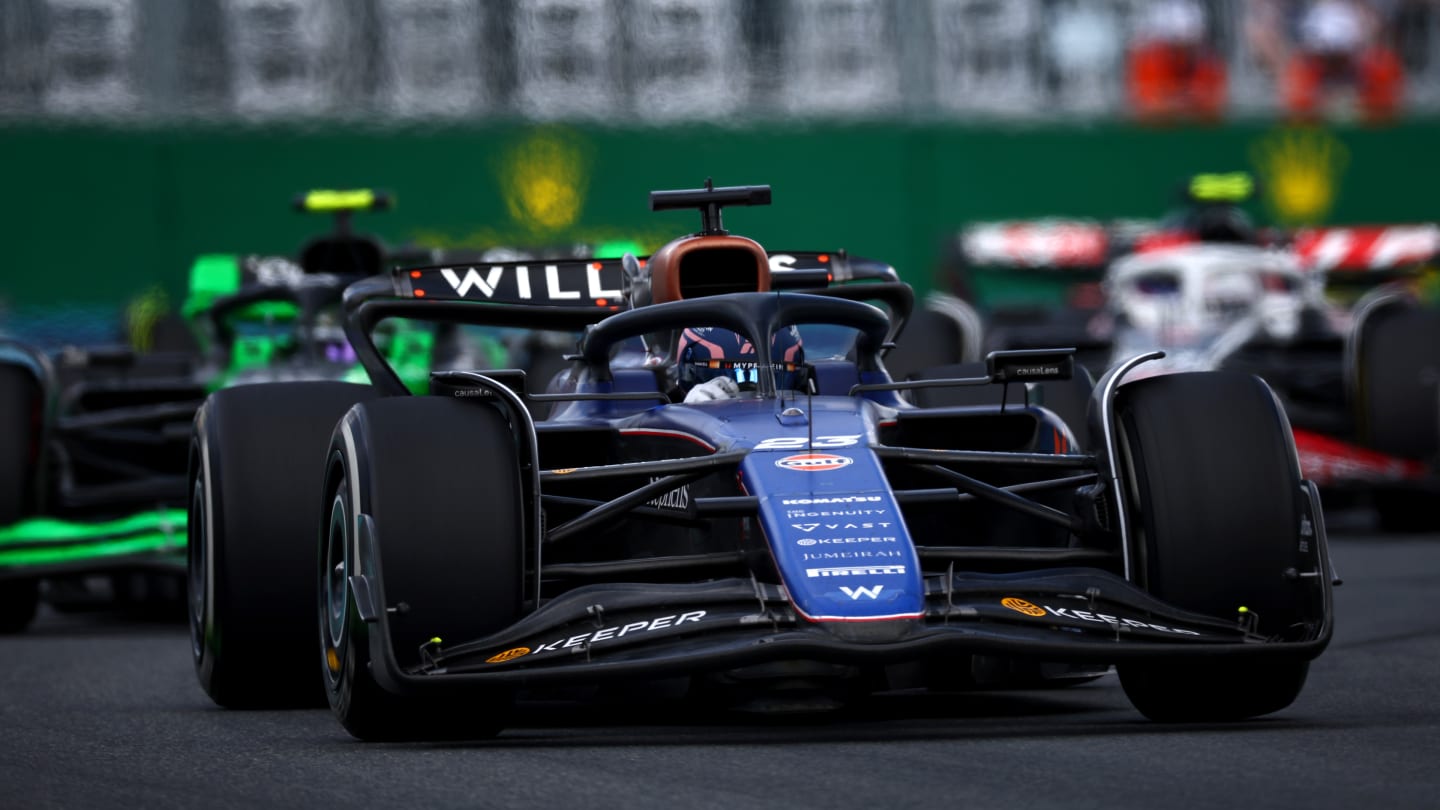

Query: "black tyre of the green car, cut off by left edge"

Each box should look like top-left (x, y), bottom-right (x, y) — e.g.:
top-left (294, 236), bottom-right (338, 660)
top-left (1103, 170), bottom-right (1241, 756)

top-left (0, 358), bottom-right (42, 633)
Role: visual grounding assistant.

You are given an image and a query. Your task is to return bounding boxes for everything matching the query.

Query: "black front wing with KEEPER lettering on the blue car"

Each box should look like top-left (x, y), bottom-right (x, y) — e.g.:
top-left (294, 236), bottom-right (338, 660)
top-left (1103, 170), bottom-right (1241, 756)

top-left (351, 559), bottom-right (1332, 693)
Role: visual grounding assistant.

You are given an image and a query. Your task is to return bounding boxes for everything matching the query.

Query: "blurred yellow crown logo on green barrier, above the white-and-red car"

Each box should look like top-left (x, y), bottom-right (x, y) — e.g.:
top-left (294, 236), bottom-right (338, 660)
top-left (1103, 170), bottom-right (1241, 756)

top-left (1250, 127), bottom-right (1349, 225)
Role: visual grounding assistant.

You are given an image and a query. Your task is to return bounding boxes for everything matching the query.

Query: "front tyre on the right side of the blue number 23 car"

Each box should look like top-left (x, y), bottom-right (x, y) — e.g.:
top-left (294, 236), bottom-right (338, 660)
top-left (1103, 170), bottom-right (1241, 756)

top-left (1116, 372), bottom-right (1309, 722)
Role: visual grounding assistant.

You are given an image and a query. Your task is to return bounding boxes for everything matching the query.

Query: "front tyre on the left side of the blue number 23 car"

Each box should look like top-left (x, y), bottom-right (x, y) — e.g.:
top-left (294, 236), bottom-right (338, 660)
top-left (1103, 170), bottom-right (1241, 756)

top-left (318, 398), bottom-right (524, 741)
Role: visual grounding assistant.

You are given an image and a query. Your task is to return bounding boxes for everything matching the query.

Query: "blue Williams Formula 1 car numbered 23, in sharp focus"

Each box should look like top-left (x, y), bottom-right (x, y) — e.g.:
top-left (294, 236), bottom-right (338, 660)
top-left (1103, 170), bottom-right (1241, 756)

top-left (189, 183), bottom-right (1333, 739)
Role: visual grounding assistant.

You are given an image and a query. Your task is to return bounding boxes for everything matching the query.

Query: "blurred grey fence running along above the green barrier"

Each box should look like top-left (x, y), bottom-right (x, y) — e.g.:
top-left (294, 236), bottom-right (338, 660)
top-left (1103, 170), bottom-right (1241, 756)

top-left (0, 0), bottom-right (1440, 124)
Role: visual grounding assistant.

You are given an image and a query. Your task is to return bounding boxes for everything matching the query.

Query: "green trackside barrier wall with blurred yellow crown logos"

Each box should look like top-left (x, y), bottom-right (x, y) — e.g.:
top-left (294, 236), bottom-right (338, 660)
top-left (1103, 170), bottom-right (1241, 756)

top-left (0, 123), bottom-right (1440, 311)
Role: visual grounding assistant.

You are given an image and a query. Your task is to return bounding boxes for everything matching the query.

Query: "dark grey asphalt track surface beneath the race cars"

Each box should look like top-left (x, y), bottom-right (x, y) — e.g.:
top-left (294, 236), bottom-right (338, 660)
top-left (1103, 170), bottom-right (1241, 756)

top-left (0, 529), bottom-right (1440, 810)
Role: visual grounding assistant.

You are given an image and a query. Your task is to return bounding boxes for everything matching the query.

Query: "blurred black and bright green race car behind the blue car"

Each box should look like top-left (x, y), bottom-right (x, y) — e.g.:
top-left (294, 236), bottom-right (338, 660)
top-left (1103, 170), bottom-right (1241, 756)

top-left (0, 190), bottom-right (457, 633)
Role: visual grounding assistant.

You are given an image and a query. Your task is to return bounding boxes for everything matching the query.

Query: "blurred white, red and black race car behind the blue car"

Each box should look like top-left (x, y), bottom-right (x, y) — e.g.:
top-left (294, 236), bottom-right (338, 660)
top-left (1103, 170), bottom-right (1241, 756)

top-left (938, 176), bottom-right (1440, 529)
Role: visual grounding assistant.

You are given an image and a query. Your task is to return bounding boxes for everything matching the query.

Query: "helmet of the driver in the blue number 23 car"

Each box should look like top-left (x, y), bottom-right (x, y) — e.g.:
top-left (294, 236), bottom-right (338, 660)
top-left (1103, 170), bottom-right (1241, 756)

top-left (675, 326), bottom-right (805, 391)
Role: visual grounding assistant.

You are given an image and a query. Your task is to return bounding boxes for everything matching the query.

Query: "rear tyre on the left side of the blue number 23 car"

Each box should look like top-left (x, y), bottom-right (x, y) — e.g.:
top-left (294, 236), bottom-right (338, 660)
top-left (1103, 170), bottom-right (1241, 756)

top-left (187, 382), bottom-right (374, 708)
